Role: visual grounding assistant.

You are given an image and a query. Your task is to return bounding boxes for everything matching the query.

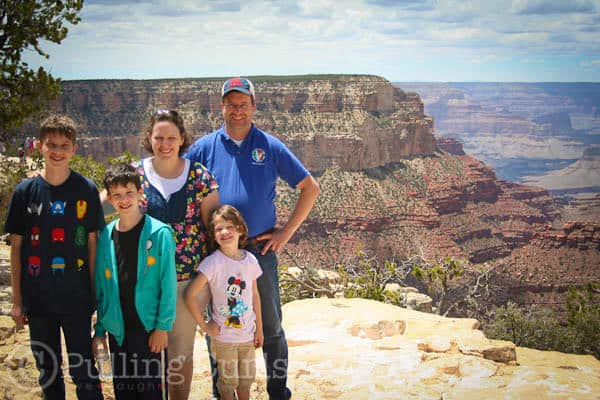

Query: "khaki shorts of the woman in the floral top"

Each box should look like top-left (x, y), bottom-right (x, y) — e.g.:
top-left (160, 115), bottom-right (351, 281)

top-left (167, 280), bottom-right (197, 372)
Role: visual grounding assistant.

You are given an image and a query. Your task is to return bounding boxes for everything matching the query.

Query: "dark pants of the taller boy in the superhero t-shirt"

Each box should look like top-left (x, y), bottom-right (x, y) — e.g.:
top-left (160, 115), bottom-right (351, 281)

top-left (29, 314), bottom-right (103, 400)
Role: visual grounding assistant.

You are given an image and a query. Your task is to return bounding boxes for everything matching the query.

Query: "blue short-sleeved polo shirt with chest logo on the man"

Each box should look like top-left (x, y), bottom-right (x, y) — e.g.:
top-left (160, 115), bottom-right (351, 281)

top-left (184, 124), bottom-right (309, 237)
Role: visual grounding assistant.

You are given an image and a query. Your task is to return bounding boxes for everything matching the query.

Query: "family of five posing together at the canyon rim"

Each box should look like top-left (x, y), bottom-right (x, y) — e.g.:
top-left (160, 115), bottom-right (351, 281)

top-left (4, 78), bottom-right (319, 400)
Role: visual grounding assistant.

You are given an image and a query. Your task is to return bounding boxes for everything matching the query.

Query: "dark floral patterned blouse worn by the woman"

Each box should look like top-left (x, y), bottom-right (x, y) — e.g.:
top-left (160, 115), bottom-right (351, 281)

top-left (135, 160), bottom-right (219, 281)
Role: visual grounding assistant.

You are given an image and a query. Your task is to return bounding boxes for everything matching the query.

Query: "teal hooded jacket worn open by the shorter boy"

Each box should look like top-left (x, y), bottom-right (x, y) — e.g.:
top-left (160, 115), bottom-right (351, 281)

top-left (94, 215), bottom-right (177, 345)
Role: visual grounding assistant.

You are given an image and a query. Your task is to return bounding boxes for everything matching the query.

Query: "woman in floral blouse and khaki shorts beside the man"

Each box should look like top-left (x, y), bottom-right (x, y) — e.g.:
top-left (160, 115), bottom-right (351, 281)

top-left (137, 110), bottom-right (219, 400)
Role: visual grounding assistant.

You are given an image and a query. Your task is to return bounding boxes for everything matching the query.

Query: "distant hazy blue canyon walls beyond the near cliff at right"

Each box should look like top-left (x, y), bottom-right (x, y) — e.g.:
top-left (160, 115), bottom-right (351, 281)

top-left (395, 82), bottom-right (600, 186)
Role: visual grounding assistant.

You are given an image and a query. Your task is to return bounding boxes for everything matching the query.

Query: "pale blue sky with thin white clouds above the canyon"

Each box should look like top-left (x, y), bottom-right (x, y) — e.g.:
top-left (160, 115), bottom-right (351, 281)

top-left (25, 0), bottom-right (600, 82)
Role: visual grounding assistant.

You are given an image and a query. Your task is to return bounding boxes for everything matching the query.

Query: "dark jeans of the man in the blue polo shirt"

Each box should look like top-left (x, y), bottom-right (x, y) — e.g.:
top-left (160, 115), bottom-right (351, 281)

top-left (206, 244), bottom-right (292, 400)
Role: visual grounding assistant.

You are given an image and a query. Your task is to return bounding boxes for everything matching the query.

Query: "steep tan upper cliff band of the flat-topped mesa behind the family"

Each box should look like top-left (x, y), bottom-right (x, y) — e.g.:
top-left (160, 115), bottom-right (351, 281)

top-left (48, 76), bottom-right (435, 171)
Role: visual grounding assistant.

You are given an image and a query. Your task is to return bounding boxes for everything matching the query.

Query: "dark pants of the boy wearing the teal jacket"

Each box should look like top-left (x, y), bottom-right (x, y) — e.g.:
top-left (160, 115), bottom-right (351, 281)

top-left (108, 331), bottom-right (168, 400)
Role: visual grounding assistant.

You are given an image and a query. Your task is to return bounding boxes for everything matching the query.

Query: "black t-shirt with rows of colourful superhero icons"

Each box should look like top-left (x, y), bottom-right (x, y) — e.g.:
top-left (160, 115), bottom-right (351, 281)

top-left (4, 171), bottom-right (104, 315)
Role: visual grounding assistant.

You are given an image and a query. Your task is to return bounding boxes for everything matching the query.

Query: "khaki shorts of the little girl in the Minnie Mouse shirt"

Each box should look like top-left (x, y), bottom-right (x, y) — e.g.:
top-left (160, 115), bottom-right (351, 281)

top-left (210, 339), bottom-right (256, 396)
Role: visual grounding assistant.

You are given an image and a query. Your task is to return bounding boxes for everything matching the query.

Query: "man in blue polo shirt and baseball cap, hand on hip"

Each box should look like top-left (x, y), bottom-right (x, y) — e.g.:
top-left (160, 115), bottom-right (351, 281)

top-left (185, 78), bottom-right (319, 400)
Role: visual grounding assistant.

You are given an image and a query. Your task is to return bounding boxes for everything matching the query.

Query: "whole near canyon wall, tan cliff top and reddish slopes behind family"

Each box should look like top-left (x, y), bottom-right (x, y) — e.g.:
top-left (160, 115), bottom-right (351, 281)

top-left (28, 75), bottom-right (600, 310)
